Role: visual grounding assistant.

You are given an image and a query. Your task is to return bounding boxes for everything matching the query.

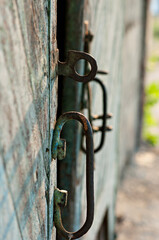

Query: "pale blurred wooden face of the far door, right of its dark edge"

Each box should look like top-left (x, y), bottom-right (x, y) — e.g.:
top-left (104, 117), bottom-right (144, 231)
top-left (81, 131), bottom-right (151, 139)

top-left (80, 0), bottom-right (144, 239)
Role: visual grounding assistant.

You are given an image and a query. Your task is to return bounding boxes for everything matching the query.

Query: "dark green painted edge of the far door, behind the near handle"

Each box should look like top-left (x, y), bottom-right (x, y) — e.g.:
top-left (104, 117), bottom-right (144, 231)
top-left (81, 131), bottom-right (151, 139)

top-left (57, 0), bottom-right (84, 240)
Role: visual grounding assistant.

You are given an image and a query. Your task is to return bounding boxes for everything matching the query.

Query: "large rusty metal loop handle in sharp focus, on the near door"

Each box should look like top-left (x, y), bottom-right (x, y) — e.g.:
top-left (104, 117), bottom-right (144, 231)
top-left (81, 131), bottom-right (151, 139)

top-left (52, 112), bottom-right (94, 239)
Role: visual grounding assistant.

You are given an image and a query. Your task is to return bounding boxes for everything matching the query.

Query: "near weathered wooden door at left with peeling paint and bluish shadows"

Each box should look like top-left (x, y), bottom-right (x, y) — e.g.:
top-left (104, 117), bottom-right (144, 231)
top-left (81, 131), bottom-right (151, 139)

top-left (0, 0), bottom-right (58, 240)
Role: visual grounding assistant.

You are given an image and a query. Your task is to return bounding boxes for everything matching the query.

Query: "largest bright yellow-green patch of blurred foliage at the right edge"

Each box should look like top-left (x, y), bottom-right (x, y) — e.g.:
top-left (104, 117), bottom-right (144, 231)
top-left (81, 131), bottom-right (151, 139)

top-left (143, 82), bottom-right (159, 146)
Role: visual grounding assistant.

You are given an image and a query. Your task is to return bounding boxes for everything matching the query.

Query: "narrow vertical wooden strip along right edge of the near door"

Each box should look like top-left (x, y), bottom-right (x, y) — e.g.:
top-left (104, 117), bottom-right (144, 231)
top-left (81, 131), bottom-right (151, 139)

top-left (48, 0), bottom-right (59, 240)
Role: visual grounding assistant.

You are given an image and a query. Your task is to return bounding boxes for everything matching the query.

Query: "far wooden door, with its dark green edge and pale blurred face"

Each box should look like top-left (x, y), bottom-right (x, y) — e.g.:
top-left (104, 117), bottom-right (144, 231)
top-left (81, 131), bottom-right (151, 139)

top-left (58, 0), bottom-right (145, 240)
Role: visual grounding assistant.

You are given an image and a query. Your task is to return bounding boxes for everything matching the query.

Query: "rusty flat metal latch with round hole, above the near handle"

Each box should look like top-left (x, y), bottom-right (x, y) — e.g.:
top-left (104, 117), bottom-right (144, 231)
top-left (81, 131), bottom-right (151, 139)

top-left (58, 50), bottom-right (97, 83)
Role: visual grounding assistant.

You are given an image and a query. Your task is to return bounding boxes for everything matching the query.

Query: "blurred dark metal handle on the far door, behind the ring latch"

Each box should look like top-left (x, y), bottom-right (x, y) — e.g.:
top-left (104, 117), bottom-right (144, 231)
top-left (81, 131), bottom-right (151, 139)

top-left (82, 78), bottom-right (112, 153)
